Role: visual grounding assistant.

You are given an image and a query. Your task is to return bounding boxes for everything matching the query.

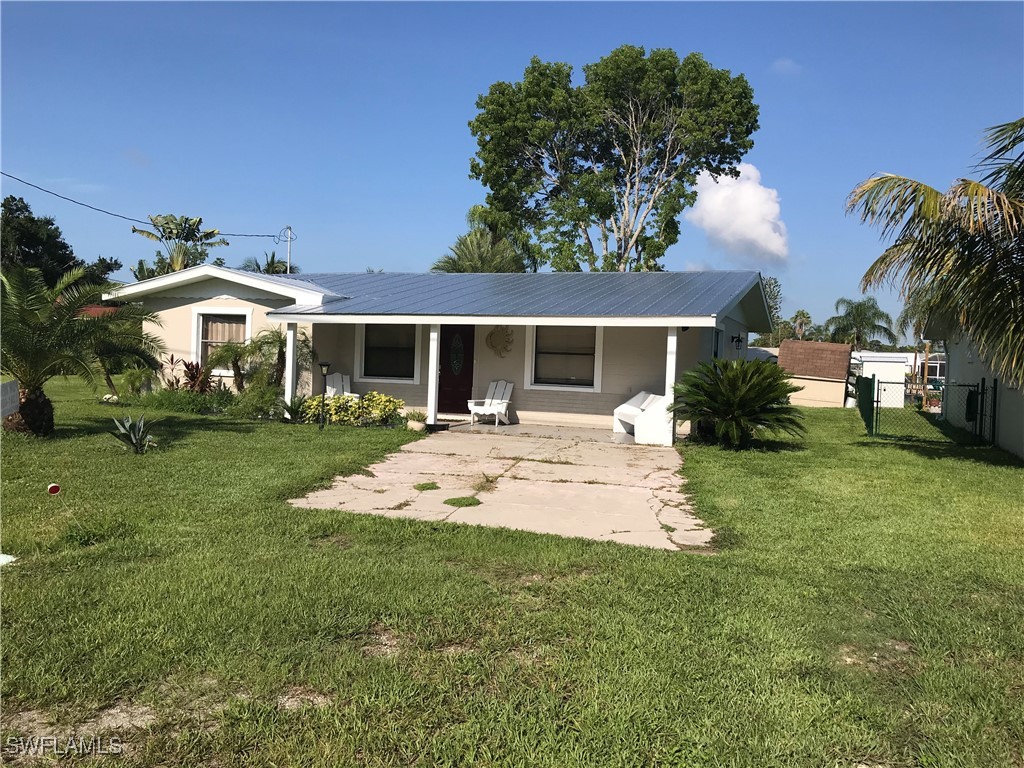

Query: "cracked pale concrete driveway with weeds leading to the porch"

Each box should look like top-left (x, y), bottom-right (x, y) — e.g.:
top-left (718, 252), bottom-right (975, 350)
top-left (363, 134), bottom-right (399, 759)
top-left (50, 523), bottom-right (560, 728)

top-left (291, 426), bottom-right (713, 550)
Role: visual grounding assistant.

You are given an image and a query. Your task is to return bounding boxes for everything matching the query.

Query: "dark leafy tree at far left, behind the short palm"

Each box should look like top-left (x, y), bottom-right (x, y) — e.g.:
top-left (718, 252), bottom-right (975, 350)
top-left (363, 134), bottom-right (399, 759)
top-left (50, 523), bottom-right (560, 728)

top-left (0, 196), bottom-right (121, 288)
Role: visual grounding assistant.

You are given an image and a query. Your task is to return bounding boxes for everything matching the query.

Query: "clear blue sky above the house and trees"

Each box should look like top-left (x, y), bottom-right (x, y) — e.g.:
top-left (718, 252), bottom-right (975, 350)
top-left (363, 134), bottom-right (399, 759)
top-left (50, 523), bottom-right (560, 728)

top-left (0, 1), bottom-right (1024, 331)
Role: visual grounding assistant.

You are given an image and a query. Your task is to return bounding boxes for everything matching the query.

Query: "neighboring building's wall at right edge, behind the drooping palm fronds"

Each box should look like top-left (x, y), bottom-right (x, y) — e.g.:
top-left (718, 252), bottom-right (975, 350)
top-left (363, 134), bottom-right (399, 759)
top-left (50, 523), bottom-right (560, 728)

top-left (925, 318), bottom-right (1024, 458)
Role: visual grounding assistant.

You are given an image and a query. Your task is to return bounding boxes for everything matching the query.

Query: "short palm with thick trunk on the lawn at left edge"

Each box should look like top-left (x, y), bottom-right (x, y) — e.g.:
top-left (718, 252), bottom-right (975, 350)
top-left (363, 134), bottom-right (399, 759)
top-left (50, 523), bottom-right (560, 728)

top-left (0, 267), bottom-right (163, 435)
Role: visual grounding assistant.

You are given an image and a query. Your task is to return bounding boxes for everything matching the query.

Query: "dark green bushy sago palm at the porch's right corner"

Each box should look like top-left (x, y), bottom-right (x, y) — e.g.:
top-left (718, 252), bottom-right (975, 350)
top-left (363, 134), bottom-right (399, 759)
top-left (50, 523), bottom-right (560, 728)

top-left (669, 360), bottom-right (807, 449)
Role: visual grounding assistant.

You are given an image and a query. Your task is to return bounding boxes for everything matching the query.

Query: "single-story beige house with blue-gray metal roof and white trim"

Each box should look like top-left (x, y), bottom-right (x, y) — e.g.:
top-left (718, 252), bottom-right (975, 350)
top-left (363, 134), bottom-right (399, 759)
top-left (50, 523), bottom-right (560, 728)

top-left (109, 264), bottom-right (771, 441)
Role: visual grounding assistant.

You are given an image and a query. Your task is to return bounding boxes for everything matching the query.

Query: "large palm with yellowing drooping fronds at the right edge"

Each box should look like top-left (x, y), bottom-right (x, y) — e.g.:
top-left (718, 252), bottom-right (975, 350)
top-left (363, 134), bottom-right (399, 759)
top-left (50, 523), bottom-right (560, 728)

top-left (847, 118), bottom-right (1024, 383)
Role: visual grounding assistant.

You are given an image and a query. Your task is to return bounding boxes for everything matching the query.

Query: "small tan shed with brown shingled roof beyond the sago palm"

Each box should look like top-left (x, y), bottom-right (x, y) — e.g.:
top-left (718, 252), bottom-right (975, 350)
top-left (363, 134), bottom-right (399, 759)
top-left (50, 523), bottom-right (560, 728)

top-left (778, 339), bottom-right (851, 408)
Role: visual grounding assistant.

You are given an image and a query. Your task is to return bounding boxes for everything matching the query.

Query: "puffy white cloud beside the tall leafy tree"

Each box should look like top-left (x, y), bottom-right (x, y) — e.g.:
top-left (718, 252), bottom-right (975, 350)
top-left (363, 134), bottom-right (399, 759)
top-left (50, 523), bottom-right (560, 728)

top-left (686, 163), bottom-right (790, 264)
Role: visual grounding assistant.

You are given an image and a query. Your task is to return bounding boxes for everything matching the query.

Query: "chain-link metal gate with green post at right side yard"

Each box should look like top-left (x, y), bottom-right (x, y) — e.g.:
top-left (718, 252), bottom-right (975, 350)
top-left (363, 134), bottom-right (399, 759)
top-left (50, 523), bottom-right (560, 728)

top-left (857, 377), bottom-right (998, 444)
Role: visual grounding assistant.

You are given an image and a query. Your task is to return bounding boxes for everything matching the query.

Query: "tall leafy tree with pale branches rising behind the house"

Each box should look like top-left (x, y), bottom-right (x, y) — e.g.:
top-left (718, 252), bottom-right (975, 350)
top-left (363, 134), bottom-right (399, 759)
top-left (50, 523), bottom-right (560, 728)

top-left (469, 45), bottom-right (758, 271)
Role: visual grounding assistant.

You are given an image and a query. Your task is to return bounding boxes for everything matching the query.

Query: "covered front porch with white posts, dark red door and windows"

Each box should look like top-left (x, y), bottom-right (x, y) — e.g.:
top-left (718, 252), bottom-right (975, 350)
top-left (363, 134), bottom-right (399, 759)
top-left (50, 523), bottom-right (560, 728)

top-left (285, 317), bottom-right (736, 445)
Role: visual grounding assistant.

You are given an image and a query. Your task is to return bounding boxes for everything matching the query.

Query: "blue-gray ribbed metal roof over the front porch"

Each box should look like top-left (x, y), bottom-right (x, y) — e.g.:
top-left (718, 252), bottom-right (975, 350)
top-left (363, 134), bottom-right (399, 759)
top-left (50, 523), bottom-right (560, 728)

top-left (273, 271), bottom-right (763, 317)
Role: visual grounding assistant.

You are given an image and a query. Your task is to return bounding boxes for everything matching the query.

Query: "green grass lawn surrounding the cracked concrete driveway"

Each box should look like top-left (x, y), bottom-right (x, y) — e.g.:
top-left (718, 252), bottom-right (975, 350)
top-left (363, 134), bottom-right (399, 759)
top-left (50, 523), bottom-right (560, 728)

top-left (2, 382), bottom-right (1024, 768)
